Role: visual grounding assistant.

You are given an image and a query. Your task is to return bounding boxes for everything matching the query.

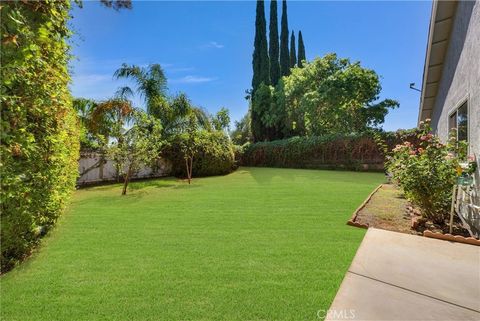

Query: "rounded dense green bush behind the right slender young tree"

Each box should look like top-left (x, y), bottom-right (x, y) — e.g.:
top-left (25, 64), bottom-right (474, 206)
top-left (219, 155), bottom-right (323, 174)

top-left (162, 131), bottom-right (236, 177)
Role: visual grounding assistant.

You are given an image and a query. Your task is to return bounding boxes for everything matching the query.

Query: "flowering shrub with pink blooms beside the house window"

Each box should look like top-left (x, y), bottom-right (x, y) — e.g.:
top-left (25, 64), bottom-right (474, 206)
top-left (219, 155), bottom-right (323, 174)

top-left (386, 122), bottom-right (459, 224)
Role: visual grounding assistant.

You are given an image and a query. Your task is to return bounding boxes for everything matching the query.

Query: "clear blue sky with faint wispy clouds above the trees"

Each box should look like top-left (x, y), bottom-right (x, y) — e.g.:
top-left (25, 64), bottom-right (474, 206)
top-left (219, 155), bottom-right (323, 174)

top-left (71, 1), bottom-right (431, 130)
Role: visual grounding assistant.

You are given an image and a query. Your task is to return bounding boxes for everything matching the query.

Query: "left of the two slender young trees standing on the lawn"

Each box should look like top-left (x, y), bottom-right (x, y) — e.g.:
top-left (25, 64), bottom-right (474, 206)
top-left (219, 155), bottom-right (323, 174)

top-left (108, 111), bottom-right (164, 195)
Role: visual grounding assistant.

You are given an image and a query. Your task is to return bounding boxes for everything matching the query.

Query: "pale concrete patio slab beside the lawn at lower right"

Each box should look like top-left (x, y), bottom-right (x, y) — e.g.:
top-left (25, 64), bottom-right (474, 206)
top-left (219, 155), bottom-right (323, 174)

top-left (326, 228), bottom-right (480, 321)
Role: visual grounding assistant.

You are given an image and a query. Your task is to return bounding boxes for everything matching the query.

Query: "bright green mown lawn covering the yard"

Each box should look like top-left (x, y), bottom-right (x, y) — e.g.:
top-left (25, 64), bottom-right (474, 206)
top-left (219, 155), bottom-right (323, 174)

top-left (0, 168), bottom-right (383, 321)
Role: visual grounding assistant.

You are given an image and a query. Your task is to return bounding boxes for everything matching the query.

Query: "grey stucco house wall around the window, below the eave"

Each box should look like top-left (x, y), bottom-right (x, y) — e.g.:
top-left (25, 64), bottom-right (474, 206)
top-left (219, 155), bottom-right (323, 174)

top-left (432, 1), bottom-right (480, 160)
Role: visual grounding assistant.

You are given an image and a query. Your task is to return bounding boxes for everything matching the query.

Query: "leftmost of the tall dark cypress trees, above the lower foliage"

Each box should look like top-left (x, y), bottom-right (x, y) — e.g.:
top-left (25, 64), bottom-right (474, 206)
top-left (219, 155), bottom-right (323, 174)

top-left (252, 0), bottom-right (270, 92)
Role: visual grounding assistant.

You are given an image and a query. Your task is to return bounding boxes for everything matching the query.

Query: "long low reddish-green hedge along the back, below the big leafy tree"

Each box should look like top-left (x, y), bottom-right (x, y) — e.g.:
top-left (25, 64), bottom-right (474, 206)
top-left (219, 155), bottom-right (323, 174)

top-left (237, 131), bottom-right (418, 171)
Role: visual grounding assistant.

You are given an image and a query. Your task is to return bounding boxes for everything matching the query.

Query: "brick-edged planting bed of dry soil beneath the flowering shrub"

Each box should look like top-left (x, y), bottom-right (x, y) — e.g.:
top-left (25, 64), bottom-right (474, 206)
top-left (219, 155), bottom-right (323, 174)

top-left (347, 184), bottom-right (480, 245)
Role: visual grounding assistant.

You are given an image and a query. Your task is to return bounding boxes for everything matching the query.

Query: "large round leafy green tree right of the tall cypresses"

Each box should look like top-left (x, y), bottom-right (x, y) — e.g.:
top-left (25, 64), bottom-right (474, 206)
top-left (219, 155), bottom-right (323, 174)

top-left (282, 54), bottom-right (399, 136)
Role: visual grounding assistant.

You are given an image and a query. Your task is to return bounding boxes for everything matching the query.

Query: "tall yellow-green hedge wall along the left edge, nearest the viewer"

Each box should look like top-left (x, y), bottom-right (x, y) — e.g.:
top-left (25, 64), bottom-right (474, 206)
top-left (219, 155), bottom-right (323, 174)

top-left (0, 1), bottom-right (79, 272)
